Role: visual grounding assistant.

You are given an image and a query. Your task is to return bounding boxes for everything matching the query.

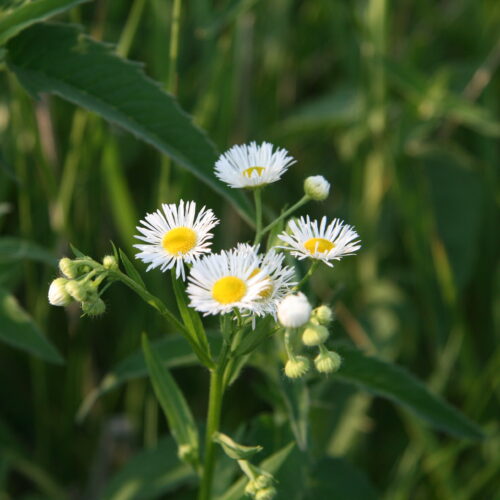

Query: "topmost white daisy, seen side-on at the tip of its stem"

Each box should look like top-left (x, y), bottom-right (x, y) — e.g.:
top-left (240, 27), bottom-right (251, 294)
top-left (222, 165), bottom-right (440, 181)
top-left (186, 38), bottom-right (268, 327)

top-left (215, 142), bottom-right (295, 188)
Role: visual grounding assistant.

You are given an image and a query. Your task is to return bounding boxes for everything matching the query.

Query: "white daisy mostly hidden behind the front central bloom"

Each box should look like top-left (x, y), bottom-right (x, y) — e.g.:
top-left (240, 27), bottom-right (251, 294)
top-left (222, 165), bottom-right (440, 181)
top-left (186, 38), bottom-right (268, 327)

top-left (237, 243), bottom-right (297, 318)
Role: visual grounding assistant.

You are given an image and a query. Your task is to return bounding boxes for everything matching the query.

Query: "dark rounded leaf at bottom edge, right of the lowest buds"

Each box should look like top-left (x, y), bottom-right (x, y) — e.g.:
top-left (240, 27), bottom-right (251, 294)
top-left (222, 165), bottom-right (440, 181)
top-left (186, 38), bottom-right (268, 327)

top-left (306, 458), bottom-right (378, 500)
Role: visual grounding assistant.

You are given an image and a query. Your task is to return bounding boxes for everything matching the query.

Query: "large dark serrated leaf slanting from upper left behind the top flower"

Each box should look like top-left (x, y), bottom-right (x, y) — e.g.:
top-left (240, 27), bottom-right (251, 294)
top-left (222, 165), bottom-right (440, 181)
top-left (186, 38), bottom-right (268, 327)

top-left (7, 24), bottom-right (253, 224)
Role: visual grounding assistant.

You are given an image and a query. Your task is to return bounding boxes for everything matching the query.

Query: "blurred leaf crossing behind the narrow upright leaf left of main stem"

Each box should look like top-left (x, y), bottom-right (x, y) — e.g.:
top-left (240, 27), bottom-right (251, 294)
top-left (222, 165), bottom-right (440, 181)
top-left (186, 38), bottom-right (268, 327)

top-left (77, 335), bottom-right (196, 422)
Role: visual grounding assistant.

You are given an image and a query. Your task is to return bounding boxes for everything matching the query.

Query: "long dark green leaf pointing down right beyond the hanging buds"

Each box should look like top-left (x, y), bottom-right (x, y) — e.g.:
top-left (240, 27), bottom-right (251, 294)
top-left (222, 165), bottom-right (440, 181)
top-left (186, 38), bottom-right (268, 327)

top-left (335, 346), bottom-right (484, 439)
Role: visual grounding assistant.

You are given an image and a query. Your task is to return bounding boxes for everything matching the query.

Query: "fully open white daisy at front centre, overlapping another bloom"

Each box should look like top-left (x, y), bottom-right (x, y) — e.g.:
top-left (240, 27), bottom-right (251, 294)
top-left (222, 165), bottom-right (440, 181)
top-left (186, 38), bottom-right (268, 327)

top-left (187, 249), bottom-right (269, 316)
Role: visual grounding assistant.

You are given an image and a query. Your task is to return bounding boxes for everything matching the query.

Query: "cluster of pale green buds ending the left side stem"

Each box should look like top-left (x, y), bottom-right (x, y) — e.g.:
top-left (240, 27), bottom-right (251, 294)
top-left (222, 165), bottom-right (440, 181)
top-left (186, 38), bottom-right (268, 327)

top-left (48, 255), bottom-right (118, 316)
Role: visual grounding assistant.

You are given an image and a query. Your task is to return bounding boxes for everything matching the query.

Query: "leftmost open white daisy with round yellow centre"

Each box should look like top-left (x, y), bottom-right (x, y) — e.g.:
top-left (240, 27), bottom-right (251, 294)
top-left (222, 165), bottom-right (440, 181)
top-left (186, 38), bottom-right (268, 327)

top-left (134, 200), bottom-right (219, 279)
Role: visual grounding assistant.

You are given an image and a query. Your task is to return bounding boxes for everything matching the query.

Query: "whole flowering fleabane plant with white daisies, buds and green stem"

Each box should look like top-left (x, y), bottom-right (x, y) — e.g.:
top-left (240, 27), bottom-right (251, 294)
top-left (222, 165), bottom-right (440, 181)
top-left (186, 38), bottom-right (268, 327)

top-left (48, 142), bottom-right (360, 500)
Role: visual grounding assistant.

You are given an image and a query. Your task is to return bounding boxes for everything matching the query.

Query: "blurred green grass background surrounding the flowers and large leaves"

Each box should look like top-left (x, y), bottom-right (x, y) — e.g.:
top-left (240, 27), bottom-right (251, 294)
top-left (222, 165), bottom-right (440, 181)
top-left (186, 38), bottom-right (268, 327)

top-left (0, 0), bottom-right (500, 500)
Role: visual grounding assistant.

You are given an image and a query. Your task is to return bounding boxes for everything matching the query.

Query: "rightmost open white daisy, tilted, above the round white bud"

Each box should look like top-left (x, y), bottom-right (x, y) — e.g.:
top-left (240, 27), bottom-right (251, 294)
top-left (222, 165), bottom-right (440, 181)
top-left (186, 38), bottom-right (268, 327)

top-left (278, 216), bottom-right (361, 267)
